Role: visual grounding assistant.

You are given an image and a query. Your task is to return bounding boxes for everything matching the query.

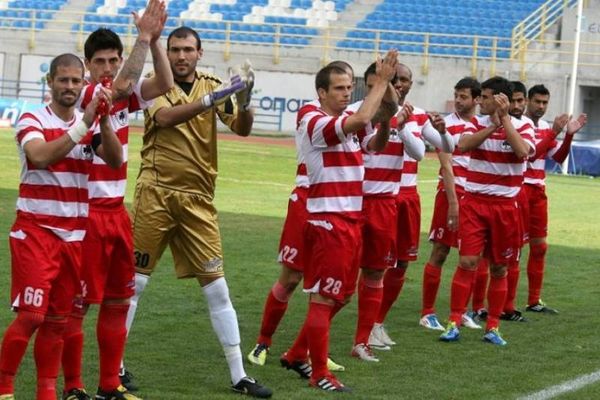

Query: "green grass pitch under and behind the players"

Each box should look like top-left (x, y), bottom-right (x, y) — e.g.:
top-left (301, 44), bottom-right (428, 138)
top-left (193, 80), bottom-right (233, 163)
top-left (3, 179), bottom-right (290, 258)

top-left (0, 130), bottom-right (600, 400)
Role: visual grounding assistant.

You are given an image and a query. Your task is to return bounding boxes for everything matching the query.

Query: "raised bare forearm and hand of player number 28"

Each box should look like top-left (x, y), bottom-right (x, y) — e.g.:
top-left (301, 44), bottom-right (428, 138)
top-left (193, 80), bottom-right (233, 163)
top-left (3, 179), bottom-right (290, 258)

top-left (343, 50), bottom-right (398, 133)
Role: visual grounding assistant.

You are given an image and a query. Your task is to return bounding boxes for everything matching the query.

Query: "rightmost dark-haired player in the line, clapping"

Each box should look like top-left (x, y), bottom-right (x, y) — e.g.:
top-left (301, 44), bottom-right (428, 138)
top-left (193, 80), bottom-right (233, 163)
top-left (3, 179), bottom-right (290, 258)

top-left (524, 85), bottom-right (587, 314)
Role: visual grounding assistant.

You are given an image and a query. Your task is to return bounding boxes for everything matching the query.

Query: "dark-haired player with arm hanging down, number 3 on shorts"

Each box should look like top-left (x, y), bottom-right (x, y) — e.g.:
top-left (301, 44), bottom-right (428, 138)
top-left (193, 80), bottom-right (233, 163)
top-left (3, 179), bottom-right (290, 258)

top-left (421, 78), bottom-right (487, 330)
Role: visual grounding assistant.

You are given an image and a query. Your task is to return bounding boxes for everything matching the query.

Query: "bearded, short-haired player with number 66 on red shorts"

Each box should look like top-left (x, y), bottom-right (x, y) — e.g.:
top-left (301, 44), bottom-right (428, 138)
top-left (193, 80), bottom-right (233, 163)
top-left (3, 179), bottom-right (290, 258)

top-left (0, 54), bottom-right (118, 400)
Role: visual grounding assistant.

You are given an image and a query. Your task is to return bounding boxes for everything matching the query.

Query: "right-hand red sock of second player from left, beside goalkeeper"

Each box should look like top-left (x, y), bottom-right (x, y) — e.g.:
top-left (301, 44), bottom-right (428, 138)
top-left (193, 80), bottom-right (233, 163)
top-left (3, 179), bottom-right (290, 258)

top-left (96, 304), bottom-right (129, 391)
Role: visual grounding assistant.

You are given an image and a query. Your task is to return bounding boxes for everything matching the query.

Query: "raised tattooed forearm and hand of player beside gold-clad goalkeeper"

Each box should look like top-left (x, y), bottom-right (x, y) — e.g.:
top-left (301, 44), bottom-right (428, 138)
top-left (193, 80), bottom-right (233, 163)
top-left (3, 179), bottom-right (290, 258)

top-left (113, 0), bottom-right (166, 100)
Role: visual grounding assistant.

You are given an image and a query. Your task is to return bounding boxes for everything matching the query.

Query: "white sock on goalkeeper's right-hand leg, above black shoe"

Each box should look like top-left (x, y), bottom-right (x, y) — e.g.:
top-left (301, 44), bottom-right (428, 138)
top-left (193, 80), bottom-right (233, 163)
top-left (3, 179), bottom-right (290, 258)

top-left (202, 278), bottom-right (246, 385)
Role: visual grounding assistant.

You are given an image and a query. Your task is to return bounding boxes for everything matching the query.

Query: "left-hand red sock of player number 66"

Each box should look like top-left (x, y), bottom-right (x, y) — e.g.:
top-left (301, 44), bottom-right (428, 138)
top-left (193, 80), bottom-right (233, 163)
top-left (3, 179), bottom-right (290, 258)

top-left (0, 311), bottom-right (44, 394)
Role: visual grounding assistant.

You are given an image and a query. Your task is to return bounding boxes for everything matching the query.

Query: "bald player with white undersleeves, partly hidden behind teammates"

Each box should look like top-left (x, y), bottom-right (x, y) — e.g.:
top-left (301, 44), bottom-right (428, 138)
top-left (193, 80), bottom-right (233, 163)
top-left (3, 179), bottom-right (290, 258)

top-left (369, 64), bottom-right (454, 348)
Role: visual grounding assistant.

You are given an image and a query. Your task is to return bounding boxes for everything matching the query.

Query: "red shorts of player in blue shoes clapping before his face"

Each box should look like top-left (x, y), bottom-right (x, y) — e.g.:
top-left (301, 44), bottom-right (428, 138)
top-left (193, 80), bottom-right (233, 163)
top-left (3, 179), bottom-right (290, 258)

top-left (458, 193), bottom-right (521, 265)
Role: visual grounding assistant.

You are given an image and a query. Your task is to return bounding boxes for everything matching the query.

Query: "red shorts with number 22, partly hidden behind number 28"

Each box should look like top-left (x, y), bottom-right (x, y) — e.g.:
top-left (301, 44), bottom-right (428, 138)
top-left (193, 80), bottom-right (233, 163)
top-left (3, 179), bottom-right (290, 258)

top-left (277, 187), bottom-right (308, 272)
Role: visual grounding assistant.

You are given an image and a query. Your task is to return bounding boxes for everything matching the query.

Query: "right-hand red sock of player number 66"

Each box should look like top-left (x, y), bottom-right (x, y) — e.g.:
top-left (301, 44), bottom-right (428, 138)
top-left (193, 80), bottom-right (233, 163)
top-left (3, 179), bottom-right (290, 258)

top-left (33, 319), bottom-right (67, 400)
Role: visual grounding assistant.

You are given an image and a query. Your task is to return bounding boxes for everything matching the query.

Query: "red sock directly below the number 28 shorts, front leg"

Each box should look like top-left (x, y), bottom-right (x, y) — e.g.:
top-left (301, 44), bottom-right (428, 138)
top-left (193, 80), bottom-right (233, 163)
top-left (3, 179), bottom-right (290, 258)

top-left (306, 302), bottom-right (331, 380)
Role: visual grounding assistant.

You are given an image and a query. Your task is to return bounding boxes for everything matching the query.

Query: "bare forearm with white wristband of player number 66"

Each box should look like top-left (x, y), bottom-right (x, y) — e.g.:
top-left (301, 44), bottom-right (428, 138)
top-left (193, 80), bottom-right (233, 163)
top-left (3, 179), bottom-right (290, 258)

top-left (23, 95), bottom-right (101, 168)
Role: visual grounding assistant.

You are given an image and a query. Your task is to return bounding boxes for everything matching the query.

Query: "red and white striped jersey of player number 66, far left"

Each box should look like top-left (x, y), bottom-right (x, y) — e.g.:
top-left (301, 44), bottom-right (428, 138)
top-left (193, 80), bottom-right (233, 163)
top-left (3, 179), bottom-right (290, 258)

top-left (16, 106), bottom-right (93, 242)
